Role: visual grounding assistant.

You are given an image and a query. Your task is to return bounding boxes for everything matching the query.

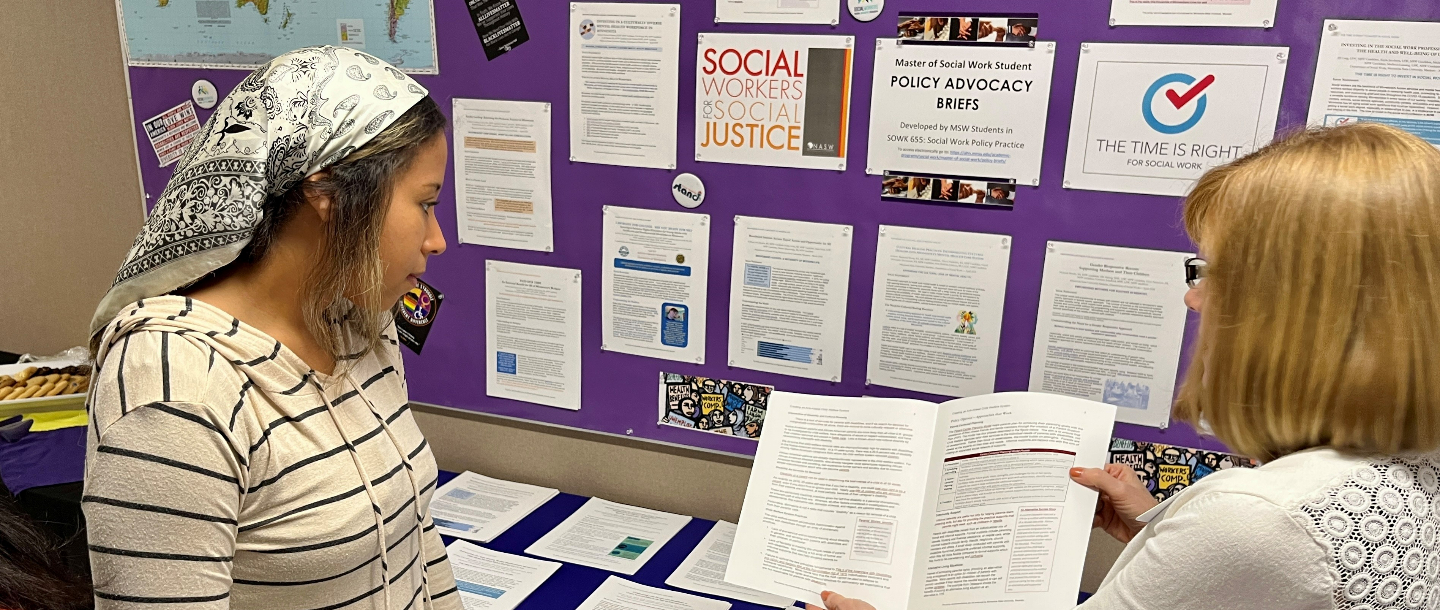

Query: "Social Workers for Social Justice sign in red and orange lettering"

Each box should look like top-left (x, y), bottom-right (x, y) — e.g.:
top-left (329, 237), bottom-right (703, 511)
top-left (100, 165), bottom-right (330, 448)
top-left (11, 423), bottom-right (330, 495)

top-left (696, 33), bottom-right (855, 170)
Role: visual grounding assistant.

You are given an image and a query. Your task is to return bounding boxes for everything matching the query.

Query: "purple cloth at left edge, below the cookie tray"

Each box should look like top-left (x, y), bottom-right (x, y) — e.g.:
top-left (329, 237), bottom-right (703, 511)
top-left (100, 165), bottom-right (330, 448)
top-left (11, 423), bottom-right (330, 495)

top-left (0, 426), bottom-right (89, 493)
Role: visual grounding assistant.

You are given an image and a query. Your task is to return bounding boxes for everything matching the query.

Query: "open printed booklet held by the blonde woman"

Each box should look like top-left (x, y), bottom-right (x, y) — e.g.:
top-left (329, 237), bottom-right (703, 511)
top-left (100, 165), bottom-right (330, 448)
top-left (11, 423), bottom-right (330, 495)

top-left (726, 391), bottom-right (1115, 610)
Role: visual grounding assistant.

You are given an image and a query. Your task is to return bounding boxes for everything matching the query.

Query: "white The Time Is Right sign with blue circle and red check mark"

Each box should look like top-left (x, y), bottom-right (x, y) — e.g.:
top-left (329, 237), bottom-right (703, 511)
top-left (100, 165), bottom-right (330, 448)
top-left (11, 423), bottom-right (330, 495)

top-left (1064, 42), bottom-right (1290, 196)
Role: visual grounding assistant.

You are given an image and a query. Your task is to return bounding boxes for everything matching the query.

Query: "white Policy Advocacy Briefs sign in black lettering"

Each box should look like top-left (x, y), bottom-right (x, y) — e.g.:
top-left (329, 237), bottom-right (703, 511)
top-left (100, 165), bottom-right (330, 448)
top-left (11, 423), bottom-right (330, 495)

top-left (865, 39), bottom-right (1056, 184)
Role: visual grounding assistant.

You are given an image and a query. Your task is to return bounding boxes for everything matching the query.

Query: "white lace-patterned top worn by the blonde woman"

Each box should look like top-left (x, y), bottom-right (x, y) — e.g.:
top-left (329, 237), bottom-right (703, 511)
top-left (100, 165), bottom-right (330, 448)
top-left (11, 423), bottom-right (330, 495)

top-left (1083, 449), bottom-right (1440, 610)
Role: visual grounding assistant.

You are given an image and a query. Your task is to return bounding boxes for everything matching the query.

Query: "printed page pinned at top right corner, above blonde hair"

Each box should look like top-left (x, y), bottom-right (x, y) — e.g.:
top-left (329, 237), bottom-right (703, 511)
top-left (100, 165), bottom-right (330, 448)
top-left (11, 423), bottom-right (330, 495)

top-left (1308, 19), bottom-right (1440, 147)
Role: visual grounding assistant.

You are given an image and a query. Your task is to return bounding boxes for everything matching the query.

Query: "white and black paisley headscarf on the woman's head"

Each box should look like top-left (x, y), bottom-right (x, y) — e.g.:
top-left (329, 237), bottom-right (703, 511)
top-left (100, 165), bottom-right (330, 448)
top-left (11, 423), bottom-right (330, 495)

top-left (91, 46), bottom-right (429, 334)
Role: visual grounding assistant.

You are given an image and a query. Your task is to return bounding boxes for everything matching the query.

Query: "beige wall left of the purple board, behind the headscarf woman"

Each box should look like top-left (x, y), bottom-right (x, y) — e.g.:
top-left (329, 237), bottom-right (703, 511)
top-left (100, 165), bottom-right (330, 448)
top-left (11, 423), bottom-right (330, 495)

top-left (0, 0), bottom-right (144, 354)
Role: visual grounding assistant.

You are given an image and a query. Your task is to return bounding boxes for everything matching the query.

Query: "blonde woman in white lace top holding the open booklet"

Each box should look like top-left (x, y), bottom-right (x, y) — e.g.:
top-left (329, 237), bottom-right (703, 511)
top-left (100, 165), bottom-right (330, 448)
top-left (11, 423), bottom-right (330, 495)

top-left (827, 124), bottom-right (1440, 610)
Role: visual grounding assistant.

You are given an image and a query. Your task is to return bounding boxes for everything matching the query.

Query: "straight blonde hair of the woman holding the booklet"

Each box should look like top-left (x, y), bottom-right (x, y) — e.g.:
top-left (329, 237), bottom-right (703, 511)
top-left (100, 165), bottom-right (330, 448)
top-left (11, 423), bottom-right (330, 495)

top-left (1175, 124), bottom-right (1440, 460)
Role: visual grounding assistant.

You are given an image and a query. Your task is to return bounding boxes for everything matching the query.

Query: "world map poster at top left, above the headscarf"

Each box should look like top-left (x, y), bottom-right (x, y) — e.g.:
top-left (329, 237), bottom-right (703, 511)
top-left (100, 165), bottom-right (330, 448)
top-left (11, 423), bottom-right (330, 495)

top-left (120, 0), bottom-right (439, 73)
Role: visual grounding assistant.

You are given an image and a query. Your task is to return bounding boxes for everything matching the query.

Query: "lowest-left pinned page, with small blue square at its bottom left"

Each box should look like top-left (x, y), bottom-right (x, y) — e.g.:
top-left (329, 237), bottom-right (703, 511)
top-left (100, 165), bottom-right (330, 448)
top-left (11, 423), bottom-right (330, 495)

top-left (485, 260), bottom-right (580, 410)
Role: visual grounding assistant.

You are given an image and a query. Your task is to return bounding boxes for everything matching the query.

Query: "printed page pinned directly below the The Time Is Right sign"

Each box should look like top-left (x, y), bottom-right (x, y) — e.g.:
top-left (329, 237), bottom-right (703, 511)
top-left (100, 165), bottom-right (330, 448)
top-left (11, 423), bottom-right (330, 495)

top-left (1030, 242), bottom-right (1195, 427)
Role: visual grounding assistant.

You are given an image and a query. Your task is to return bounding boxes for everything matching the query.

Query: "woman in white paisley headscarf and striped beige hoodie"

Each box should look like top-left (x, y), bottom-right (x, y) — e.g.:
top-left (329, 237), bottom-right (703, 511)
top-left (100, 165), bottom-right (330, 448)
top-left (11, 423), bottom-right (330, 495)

top-left (84, 46), bottom-right (461, 610)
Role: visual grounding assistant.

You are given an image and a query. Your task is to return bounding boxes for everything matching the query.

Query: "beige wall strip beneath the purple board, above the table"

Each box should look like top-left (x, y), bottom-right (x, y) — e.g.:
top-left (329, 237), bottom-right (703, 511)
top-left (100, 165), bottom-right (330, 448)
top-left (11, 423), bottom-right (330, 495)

top-left (412, 403), bottom-right (1125, 591)
